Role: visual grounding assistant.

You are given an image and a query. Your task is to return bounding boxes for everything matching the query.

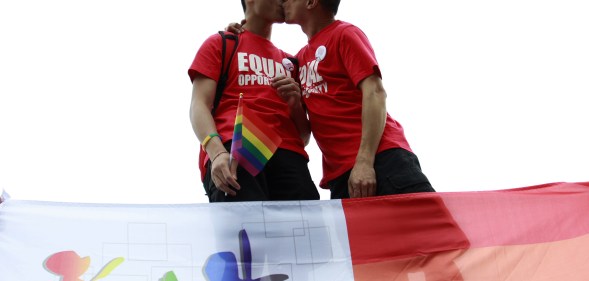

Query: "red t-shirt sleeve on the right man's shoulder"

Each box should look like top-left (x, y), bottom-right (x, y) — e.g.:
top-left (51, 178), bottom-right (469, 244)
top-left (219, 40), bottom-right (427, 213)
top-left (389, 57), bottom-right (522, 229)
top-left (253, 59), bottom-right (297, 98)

top-left (339, 26), bottom-right (381, 86)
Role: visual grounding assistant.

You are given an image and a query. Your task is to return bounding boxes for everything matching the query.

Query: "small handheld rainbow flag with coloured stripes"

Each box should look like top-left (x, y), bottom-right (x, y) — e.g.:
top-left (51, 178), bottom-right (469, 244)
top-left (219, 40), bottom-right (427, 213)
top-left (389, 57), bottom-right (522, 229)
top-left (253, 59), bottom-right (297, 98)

top-left (231, 94), bottom-right (282, 176)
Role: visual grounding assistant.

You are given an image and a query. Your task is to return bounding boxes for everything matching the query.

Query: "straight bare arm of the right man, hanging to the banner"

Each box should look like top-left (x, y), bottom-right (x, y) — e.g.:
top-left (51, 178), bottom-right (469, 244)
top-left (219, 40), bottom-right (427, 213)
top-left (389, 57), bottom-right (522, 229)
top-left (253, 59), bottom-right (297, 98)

top-left (348, 74), bottom-right (387, 198)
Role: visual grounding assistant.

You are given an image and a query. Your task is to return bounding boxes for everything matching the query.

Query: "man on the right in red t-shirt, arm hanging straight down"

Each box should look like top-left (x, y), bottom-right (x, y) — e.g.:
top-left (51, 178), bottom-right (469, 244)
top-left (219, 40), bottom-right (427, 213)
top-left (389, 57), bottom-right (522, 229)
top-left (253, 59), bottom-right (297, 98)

top-left (283, 0), bottom-right (435, 199)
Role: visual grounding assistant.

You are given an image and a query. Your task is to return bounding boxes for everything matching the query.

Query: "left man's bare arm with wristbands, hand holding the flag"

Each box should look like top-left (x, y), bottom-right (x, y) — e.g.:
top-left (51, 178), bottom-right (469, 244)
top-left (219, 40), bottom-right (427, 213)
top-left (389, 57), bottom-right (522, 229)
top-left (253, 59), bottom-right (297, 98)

top-left (190, 75), bottom-right (240, 196)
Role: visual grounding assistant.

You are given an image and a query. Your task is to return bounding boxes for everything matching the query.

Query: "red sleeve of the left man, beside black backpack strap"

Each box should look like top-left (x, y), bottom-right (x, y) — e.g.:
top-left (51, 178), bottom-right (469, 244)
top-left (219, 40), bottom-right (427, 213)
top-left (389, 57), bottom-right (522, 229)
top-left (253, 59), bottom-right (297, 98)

top-left (188, 34), bottom-right (221, 83)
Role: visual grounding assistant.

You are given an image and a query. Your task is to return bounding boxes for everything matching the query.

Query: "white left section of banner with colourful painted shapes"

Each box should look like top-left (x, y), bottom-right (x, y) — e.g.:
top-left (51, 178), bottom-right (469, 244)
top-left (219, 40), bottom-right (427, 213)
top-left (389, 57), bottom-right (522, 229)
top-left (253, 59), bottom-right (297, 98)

top-left (0, 199), bottom-right (354, 281)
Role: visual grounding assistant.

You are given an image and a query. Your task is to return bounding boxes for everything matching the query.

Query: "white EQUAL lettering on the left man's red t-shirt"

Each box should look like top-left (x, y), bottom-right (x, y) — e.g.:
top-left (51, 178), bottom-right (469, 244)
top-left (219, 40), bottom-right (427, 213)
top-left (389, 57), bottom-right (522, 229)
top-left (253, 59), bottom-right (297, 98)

top-left (237, 52), bottom-right (291, 86)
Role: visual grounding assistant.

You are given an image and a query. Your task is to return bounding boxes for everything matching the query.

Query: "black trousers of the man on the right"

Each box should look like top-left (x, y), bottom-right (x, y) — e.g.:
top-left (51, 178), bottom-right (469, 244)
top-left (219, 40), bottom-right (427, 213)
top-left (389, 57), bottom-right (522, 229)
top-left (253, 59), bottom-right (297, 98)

top-left (328, 148), bottom-right (435, 199)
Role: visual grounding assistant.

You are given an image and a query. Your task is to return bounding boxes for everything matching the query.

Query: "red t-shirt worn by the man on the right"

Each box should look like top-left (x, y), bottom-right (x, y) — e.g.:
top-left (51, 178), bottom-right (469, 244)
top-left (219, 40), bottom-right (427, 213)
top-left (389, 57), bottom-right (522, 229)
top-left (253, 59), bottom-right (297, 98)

top-left (297, 21), bottom-right (411, 188)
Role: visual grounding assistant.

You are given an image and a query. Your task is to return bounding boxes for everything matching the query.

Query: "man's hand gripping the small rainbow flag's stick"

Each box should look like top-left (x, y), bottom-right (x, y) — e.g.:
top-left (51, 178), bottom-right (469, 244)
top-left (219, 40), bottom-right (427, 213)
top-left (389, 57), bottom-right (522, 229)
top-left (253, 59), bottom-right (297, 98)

top-left (211, 151), bottom-right (241, 196)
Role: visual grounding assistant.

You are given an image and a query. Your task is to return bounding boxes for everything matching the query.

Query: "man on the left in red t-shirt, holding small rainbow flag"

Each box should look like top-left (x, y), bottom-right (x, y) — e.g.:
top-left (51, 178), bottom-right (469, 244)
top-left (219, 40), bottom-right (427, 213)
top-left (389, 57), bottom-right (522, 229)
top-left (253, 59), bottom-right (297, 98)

top-left (188, 0), bottom-right (319, 202)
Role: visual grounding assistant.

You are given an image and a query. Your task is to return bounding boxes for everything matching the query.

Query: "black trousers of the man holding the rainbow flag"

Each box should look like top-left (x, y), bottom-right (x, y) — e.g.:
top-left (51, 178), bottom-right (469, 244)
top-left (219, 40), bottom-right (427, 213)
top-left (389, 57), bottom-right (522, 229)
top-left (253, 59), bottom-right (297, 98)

top-left (203, 142), bottom-right (319, 202)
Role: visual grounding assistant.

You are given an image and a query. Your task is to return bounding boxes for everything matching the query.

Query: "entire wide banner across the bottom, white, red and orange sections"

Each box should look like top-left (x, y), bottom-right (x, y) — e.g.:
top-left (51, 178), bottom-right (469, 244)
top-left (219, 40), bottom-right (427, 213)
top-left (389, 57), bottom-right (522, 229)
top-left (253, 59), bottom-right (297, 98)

top-left (0, 182), bottom-right (589, 281)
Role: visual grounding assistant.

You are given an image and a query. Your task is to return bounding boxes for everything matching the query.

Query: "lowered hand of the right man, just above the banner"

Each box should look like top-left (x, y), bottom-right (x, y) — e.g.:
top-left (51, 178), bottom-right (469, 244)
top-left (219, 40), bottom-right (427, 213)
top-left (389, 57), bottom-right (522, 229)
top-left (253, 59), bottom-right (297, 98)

top-left (348, 162), bottom-right (376, 198)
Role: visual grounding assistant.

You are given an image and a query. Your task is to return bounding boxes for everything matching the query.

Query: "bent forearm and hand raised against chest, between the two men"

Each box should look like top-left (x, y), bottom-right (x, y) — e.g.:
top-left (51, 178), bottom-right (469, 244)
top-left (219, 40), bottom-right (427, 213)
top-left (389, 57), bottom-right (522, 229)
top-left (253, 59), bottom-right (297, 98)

top-left (272, 76), bottom-right (311, 145)
